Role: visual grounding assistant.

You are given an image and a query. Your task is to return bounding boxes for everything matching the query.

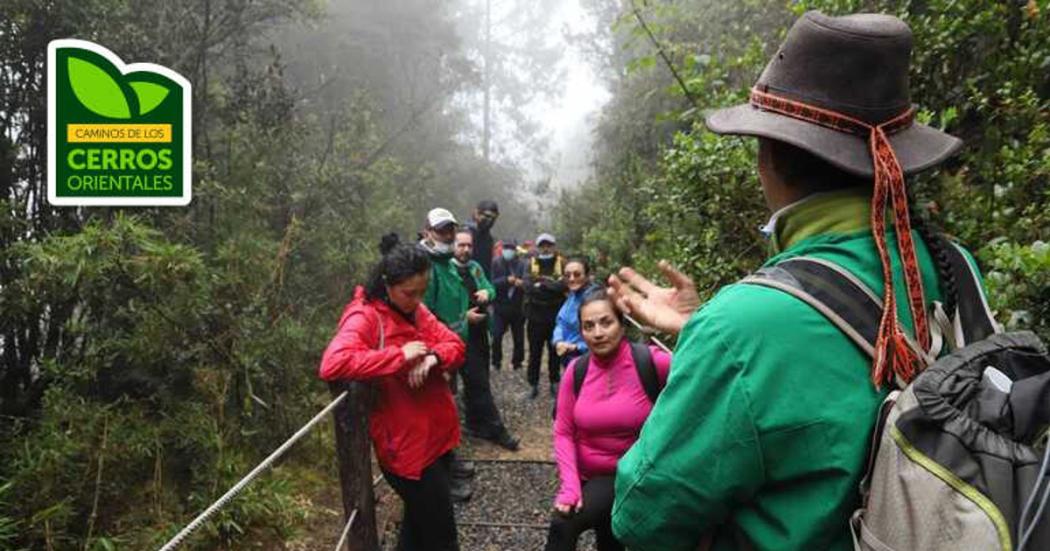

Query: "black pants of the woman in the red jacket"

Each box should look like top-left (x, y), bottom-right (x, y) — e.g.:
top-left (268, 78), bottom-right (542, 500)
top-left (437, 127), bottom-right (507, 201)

top-left (382, 453), bottom-right (459, 551)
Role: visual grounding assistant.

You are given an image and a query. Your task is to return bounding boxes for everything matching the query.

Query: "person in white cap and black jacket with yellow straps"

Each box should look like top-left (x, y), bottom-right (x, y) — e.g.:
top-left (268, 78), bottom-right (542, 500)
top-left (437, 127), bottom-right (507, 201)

top-left (525, 233), bottom-right (565, 399)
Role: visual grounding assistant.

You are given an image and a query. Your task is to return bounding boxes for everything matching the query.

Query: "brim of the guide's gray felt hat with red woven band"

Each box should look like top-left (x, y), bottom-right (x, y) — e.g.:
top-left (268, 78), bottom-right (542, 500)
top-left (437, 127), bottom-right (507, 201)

top-left (706, 104), bottom-right (963, 176)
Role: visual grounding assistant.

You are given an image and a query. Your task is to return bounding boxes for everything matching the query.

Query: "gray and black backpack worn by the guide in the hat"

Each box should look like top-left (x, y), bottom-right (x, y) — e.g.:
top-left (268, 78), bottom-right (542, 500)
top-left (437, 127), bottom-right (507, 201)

top-left (743, 247), bottom-right (1050, 551)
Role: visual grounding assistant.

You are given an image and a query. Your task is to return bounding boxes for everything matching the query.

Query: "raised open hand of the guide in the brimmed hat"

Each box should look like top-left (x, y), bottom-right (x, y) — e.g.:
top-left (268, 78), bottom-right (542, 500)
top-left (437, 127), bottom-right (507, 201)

top-left (608, 260), bottom-right (700, 334)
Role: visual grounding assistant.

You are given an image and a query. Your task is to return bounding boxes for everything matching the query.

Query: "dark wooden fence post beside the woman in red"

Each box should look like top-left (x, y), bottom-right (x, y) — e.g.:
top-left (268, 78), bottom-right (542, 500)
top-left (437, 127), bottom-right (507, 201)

top-left (329, 382), bottom-right (379, 551)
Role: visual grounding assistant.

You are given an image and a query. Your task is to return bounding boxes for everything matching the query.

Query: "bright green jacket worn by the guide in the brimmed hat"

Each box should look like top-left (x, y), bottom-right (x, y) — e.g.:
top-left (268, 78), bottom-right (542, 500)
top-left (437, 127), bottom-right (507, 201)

top-left (612, 188), bottom-right (982, 551)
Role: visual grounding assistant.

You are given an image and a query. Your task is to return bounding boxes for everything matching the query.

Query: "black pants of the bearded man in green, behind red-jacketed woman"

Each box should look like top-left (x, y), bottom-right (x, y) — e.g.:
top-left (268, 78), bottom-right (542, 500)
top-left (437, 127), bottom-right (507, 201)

top-left (460, 323), bottom-right (506, 439)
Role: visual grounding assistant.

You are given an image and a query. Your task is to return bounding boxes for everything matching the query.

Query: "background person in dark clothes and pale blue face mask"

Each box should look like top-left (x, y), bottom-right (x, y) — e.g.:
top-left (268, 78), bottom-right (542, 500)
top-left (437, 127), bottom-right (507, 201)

top-left (492, 239), bottom-right (525, 369)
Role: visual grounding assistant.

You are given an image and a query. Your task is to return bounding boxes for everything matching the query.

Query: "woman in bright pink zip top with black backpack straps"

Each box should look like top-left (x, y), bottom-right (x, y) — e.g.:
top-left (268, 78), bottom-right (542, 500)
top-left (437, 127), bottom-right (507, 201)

top-left (546, 290), bottom-right (671, 551)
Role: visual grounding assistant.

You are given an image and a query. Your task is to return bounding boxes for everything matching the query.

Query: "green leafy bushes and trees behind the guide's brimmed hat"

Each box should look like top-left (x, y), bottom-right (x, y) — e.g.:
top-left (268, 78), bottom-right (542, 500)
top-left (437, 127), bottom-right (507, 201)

top-left (558, 0), bottom-right (1050, 339)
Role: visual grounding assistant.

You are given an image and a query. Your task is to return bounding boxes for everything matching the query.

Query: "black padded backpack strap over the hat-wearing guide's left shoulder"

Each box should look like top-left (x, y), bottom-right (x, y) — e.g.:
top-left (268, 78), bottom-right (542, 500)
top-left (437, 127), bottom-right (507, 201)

top-left (741, 256), bottom-right (882, 357)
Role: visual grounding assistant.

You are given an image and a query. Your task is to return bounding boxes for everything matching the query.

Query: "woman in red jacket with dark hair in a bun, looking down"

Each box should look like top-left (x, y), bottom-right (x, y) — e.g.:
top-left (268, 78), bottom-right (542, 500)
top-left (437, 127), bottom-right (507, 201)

top-left (320, 234), bottom-right (465, 551)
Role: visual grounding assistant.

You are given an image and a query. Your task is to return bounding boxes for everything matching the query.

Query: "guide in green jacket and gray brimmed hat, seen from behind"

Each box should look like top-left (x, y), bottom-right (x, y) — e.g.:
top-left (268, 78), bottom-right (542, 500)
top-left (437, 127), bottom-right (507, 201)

top-left (609, 13), bottom-right (972, 551)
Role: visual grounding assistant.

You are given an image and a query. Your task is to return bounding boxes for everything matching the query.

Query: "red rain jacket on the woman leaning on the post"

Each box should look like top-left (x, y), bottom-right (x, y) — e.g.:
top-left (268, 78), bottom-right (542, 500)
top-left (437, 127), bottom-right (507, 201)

top-left (320, 287), bottom-right (466, 480)
